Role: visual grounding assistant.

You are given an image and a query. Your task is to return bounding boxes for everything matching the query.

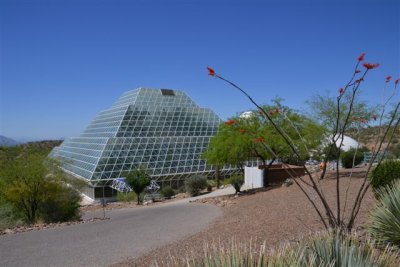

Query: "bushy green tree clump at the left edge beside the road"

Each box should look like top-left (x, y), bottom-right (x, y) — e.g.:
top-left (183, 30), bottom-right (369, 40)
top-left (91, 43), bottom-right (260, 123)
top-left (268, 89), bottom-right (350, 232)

top-left (0, 153), bottom-right (81, 224)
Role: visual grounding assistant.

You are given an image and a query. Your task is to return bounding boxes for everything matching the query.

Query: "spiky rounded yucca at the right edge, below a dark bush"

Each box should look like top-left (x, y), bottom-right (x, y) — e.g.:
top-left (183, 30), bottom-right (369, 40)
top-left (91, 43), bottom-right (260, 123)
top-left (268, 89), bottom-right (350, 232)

top-left (368, 180), bottom-right (400, 249)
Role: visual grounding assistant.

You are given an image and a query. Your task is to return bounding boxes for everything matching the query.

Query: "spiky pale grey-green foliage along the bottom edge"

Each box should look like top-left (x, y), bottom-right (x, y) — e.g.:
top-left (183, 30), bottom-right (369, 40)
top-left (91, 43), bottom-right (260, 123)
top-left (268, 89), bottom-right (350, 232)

top-left (162, 232), bottom-right (398, 267)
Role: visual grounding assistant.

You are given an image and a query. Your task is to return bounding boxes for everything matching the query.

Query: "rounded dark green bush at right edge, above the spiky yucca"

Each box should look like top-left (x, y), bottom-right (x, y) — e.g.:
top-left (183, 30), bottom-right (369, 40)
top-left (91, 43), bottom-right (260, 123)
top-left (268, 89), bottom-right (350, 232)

top-left (369, 160), bottom-right (400, 190)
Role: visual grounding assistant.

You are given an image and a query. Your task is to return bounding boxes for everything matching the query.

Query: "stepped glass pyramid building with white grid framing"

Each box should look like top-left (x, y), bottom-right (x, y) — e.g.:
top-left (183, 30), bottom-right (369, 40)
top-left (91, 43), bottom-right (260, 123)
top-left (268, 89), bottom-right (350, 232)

top-left (50, 88), bottom-right (233, 197)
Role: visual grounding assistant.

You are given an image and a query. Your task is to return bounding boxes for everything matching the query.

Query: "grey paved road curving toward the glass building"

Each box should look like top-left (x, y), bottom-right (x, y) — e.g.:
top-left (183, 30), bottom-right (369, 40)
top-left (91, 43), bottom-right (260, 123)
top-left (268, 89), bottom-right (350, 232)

top-left (0, 202), bottom-right (221, 266)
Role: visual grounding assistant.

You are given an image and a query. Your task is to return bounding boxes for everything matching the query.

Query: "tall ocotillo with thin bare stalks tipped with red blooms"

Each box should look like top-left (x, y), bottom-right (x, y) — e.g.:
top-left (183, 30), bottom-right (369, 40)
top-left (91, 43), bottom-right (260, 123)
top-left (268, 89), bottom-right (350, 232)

top-left (207, 53), bottom-right (400, 232)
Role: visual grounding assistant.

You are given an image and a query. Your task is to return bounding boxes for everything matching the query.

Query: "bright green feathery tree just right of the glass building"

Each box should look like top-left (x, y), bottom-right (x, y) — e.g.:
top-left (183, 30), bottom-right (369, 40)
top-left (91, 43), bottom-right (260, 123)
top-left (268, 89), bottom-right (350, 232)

top-left (203, 100), bottom-right (325, 185)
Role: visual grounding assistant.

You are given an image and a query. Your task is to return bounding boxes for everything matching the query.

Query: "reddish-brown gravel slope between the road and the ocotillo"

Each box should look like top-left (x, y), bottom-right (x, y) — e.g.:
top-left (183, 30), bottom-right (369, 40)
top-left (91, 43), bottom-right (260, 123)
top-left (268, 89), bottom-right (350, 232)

top-left (115, 170), bottom-right (375, 266)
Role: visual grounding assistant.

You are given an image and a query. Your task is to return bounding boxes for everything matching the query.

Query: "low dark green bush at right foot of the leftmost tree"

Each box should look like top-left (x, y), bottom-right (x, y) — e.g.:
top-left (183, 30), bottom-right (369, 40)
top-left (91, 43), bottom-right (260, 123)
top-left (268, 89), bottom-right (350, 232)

top-left (39, 182), bottom-right (81, 223)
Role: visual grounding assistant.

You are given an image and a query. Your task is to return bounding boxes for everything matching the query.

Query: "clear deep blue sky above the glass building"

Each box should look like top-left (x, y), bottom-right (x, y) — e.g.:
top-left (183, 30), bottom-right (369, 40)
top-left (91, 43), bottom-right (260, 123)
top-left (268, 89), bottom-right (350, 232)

top-left (0, 0), bottom-right (400, 139)
